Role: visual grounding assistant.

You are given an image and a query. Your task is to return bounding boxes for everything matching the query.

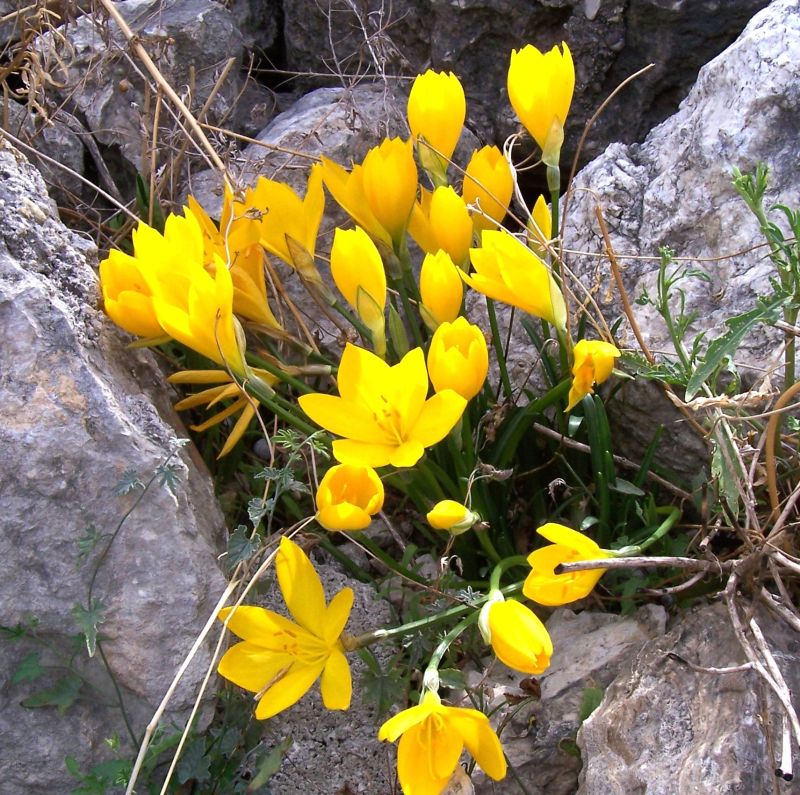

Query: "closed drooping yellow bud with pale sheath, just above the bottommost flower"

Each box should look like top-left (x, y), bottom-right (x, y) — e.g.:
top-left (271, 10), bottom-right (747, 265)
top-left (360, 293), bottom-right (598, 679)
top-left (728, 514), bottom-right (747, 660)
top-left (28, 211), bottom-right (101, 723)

top-left (478, 591), bottom-right (553, 674)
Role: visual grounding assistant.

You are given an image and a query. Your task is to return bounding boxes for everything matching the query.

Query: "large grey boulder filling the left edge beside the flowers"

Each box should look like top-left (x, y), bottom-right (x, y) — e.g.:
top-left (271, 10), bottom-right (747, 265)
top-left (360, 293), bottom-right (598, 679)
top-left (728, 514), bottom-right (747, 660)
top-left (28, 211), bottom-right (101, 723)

top-left (0, 142), bottom-right (224, 795)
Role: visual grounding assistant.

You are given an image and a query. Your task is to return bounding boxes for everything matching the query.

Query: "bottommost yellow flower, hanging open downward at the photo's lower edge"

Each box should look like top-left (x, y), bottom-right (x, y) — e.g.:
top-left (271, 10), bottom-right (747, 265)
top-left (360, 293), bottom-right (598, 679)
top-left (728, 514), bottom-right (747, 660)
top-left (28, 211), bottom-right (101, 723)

top-left (378, 690), bottom-right (506, 795)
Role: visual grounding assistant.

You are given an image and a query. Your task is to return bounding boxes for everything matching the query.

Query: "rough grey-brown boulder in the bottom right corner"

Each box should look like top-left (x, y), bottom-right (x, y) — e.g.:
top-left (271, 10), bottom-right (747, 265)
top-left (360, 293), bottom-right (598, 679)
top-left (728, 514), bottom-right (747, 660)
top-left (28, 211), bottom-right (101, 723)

top-left (578, 604), bottom-right (800, 795)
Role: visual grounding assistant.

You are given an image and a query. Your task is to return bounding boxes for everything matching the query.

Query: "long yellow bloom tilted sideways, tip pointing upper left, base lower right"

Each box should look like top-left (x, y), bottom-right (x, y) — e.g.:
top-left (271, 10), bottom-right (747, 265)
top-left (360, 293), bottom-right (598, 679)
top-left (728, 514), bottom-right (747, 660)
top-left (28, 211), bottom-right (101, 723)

top-left (462, 229), bottom-right (567, 330)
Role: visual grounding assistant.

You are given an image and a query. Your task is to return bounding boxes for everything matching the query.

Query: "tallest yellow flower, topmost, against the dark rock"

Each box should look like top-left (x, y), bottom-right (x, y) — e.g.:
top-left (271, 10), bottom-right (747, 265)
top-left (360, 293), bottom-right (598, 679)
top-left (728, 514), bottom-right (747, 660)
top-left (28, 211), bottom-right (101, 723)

top-left (508, 42), bottom-right (575, 166)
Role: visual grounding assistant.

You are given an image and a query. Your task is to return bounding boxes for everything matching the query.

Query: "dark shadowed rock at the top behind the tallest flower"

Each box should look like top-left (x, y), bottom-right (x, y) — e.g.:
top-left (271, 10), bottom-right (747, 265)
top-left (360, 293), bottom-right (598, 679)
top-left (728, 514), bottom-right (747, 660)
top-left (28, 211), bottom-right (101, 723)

top-left (284, 0), bottom-right (767, 163)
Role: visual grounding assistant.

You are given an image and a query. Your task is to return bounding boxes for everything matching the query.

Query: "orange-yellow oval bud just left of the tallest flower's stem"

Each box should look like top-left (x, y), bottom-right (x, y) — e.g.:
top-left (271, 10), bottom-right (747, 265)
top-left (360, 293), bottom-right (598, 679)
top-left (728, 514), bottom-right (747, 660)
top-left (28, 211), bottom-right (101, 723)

top-left (461, 146), bottom-right (514, 234)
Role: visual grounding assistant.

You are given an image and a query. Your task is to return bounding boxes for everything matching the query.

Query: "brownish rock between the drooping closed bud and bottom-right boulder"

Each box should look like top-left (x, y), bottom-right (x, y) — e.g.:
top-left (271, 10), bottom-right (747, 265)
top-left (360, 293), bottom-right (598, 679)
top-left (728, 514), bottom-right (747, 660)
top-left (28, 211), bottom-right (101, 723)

top-left (468, 605), bottom-right (667, 795)
